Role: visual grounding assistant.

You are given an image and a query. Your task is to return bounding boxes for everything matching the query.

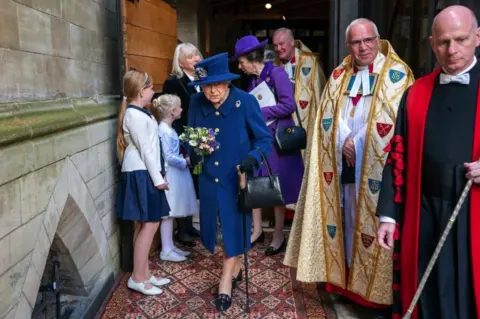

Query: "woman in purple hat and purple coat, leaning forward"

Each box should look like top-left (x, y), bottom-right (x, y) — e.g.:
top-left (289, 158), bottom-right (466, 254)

top-left (231, 35), bottom-right (304, 256)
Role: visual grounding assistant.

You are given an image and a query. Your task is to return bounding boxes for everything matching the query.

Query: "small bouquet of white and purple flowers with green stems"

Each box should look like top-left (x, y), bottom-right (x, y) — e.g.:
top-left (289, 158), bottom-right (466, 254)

top-left (179, 126), bottom-right (220, 175)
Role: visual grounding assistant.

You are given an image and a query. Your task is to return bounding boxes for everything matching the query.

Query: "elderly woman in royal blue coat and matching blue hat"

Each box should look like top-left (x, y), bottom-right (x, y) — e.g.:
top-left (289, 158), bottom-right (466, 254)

top-left (188, 53), bottom-right (273, 311)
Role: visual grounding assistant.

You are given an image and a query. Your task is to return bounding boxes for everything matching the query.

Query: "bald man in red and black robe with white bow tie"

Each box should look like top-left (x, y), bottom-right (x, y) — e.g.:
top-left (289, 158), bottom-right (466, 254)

top-left (377, 6), bottom-right (480, 319)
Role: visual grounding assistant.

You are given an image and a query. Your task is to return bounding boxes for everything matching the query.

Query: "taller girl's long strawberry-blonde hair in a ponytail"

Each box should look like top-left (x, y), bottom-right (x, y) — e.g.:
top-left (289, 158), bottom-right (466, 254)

top-left (117, 70), bottom-right (153, 162)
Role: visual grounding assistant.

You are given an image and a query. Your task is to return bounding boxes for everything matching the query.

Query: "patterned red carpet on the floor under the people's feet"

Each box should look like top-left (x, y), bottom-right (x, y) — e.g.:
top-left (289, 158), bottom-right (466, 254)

top-left (98, 239), bottom-right (336, 319)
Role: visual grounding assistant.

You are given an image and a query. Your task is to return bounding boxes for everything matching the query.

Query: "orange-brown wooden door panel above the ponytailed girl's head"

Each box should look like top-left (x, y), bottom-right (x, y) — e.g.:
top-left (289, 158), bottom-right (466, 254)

top-left (122, 0), bottom-right (177, 92)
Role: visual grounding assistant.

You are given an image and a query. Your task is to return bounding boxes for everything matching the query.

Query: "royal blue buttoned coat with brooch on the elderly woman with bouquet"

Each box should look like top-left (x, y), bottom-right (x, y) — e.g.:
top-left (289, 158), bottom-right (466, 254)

top-left (188, 86), bottom-right (273, 258)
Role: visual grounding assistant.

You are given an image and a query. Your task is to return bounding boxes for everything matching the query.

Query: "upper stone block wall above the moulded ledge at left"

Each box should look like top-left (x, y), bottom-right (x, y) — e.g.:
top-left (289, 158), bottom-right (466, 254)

top-left (0, 0), bottom-right (120, 101)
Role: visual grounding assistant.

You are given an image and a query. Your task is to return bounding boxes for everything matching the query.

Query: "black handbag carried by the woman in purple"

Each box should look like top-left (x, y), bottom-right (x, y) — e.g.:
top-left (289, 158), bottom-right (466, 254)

top-left (275, 106), bottom-right (307, 153)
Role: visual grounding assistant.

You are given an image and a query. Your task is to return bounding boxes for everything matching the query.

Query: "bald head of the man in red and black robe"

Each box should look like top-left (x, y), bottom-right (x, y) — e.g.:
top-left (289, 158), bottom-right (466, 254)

top-left (430, 5), bottom-right (480, 74)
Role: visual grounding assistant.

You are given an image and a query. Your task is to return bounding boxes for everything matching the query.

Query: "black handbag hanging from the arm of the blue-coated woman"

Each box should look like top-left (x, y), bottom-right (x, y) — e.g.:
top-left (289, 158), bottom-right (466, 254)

top-left (239, 148), bottom-right (284, 210)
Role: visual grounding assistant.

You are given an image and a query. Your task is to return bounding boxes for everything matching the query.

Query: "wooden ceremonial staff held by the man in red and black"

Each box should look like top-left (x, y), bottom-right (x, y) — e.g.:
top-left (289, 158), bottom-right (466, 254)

top-left (402, 176), bottom-right (473, 319)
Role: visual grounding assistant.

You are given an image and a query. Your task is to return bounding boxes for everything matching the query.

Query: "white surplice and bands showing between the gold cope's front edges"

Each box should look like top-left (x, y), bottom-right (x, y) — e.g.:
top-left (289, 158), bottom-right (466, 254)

top-left (337, 66), bottom-right (372, 266)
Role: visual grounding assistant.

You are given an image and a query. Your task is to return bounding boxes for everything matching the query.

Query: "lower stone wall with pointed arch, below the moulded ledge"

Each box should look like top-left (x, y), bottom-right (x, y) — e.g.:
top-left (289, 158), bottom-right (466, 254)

top-left (0, 109), bottom-right (119, 319)
